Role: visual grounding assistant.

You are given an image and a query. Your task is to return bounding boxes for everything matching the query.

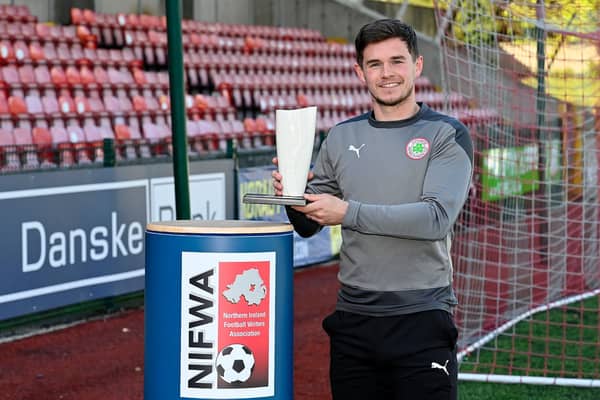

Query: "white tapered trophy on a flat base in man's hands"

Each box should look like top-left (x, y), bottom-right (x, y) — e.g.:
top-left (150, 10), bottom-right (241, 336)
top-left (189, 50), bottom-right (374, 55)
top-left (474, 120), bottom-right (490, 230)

top-left (243, 106), bottom-right (317, 205)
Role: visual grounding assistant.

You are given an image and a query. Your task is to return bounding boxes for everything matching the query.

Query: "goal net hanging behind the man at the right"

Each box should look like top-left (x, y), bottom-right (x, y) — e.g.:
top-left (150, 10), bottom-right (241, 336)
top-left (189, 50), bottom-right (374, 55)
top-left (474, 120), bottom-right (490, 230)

top-left (435, 0), bottom-right (600, 387)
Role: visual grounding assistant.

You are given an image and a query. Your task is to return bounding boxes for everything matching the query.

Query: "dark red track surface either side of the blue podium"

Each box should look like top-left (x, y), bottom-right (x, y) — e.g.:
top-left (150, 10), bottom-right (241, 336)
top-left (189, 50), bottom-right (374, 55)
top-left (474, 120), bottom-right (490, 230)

top-left (0, 265), bottom-right (338, 400)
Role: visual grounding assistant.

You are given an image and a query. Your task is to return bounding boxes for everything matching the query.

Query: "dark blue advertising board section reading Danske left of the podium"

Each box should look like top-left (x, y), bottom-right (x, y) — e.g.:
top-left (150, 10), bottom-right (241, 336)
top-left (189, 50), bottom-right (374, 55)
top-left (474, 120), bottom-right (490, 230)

top-left (0, 179), bottom-right (149, 320)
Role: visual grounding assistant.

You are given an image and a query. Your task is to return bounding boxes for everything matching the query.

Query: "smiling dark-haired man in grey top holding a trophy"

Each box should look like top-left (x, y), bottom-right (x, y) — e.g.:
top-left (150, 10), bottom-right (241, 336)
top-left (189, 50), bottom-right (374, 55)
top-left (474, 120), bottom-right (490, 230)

top-left (273, 19), bottom-right (473, 400)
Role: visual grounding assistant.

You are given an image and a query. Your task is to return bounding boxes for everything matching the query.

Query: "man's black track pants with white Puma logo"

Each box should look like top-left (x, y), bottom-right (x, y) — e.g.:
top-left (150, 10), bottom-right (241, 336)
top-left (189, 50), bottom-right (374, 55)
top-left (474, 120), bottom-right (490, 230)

top-left (323, 310), bottom-right (458, 400)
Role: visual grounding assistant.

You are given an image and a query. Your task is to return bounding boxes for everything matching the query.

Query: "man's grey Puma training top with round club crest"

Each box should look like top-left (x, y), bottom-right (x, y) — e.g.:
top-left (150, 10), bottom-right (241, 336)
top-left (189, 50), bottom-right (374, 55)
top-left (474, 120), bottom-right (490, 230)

top-left (287, 103), bottom-right (473, 316)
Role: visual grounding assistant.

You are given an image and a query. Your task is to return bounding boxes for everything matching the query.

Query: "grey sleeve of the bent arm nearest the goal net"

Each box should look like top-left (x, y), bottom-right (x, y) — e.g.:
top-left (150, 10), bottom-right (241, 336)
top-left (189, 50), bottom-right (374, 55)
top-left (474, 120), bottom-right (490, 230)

top-left (342, 127), bottom-right (473, 240)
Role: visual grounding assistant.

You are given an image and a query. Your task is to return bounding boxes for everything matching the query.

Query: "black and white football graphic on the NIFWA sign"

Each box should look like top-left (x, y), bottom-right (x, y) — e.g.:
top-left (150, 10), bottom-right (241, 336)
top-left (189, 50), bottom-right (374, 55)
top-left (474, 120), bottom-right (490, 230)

top-left (216, 344), bottom-right (254, 383)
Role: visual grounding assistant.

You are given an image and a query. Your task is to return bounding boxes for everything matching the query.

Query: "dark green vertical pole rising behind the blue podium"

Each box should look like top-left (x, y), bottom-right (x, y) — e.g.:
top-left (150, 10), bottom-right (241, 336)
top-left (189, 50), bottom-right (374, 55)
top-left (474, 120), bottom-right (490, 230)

top-left (165, 0), bottom-right (191, 220)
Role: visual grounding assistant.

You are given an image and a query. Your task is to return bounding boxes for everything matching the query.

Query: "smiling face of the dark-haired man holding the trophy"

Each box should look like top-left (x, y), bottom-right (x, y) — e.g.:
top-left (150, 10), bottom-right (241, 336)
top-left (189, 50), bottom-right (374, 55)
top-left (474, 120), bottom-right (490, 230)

top-left (354, 38), bottom-right (423, 107)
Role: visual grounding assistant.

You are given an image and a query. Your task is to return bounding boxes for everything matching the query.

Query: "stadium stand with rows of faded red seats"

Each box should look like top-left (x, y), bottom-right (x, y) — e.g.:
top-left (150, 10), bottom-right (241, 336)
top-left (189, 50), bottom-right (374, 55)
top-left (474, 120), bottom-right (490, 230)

top-left (0, 6), bottom-right (496, 172)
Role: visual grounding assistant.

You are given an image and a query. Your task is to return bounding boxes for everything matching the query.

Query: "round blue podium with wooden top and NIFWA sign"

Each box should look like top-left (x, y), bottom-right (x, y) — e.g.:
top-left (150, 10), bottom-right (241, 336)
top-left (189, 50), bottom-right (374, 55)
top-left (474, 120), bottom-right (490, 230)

top-left (144, 220), bottom-right (293, 400)
